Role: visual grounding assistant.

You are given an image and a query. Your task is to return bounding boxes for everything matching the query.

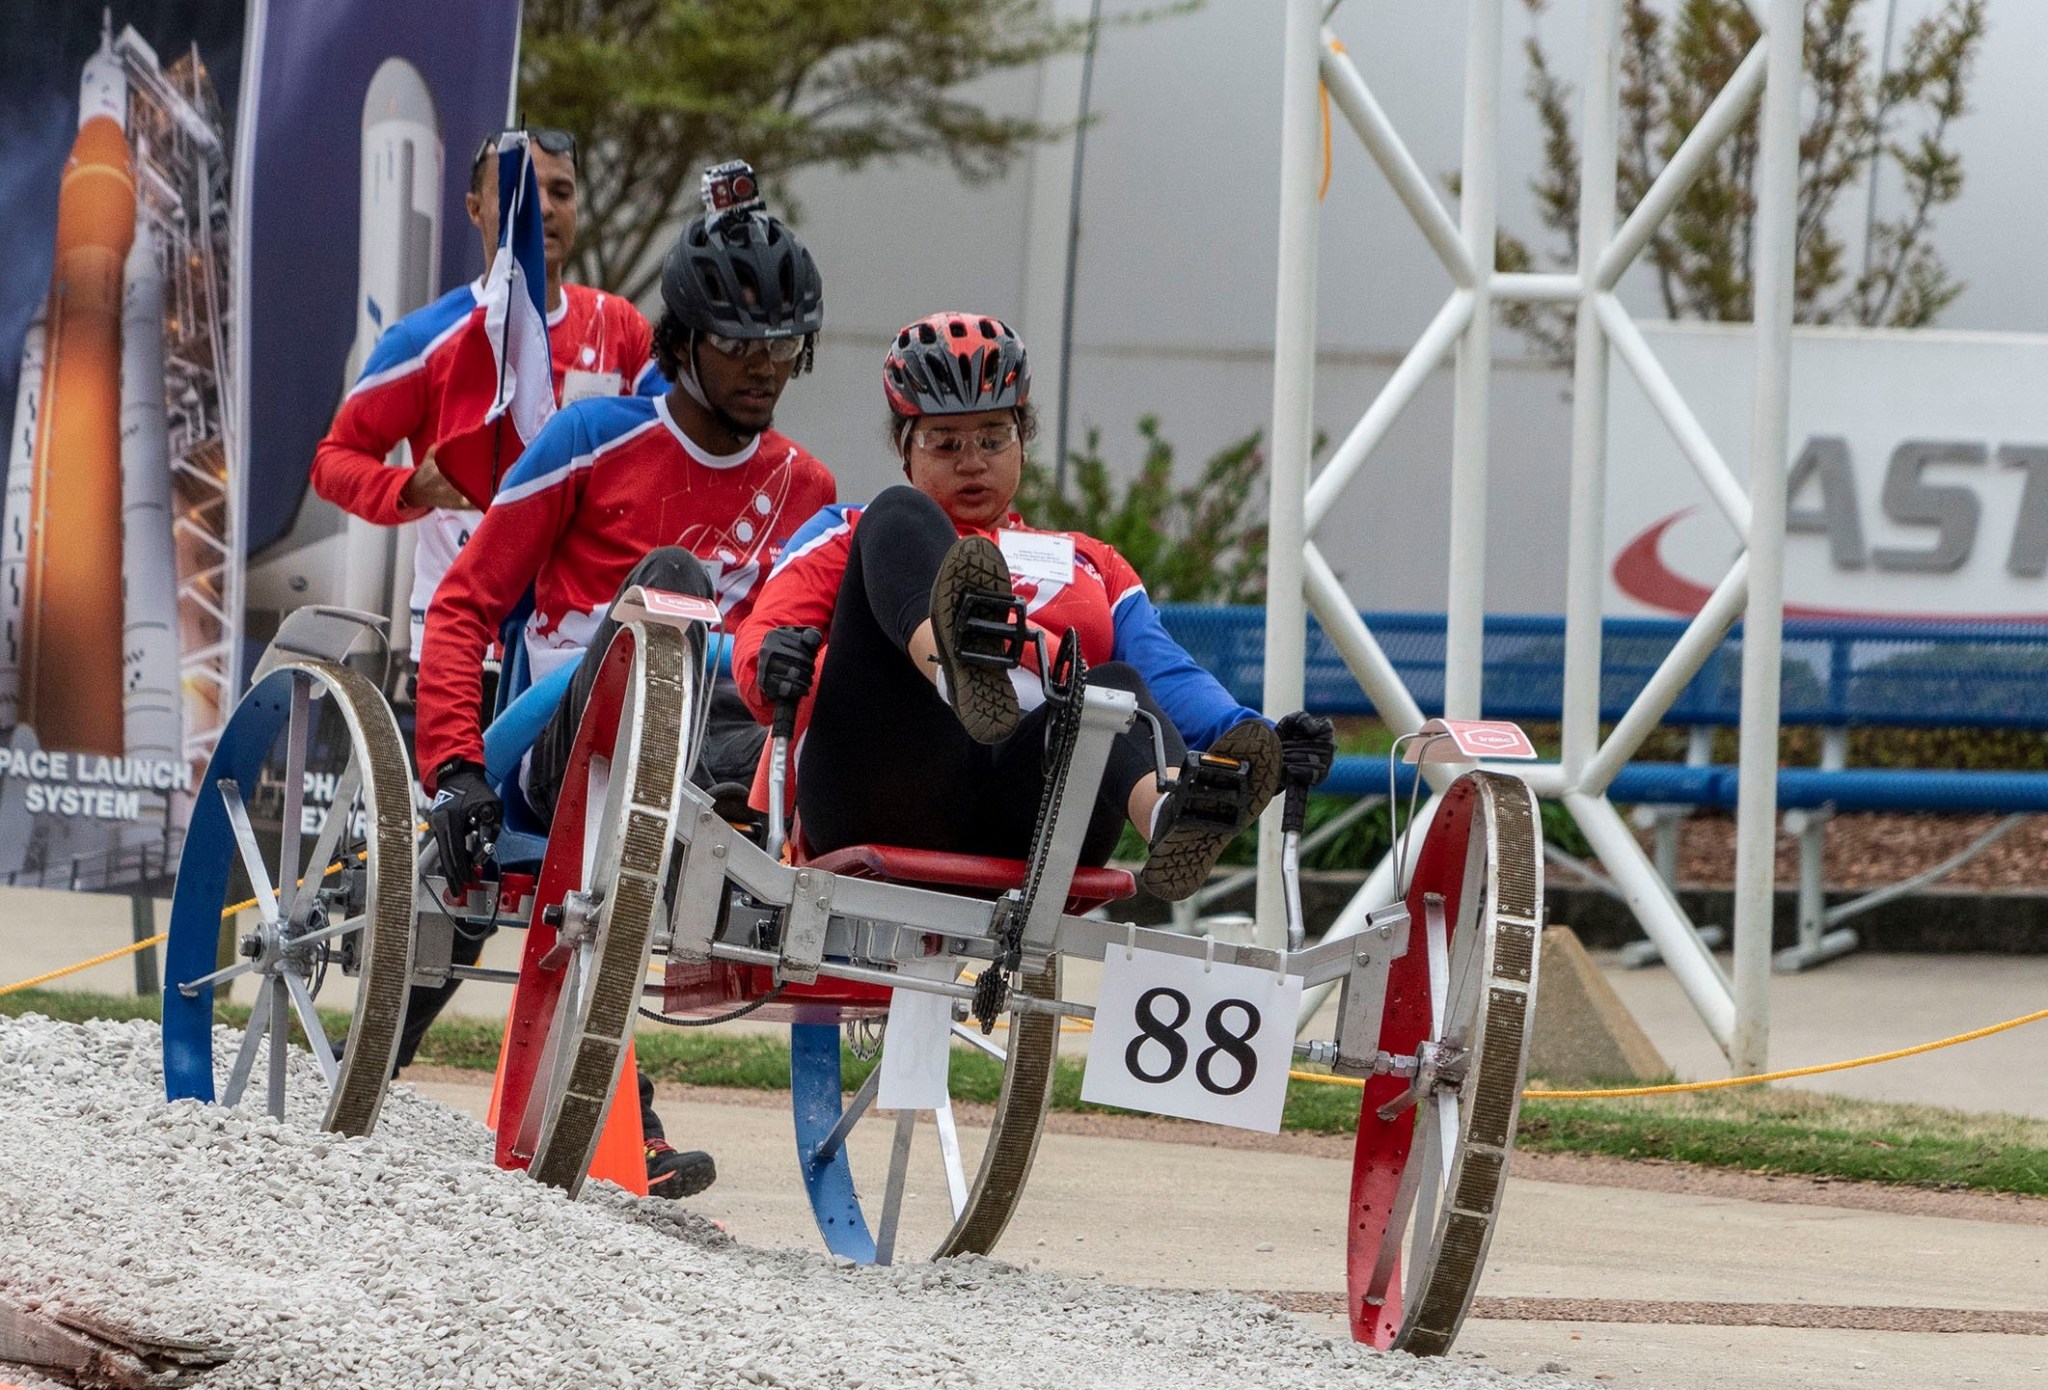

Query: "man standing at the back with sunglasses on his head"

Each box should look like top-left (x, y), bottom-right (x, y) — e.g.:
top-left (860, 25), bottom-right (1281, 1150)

top-left (313, 129), bottom-right (666, 663)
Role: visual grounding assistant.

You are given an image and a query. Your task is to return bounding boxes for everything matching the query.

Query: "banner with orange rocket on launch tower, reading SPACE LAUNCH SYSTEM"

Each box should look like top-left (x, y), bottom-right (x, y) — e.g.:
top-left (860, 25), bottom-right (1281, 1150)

top-left (0, 6), bottom-right (242, 886)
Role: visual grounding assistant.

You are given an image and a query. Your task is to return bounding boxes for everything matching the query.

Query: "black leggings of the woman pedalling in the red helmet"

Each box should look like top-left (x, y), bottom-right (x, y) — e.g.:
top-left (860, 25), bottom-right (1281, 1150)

top-left (797, 487), bottom-right (1188, 866)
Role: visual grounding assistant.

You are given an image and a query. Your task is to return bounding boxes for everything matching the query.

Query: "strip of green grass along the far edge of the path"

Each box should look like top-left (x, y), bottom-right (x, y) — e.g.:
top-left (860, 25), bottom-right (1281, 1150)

top-left (16, 991), bottom-right (2048, 1196)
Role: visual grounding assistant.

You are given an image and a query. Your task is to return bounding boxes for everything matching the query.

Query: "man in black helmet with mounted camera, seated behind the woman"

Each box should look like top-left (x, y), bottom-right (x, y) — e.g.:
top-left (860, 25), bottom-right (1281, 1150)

top-left (416, 164), bottom-right (838, 1196)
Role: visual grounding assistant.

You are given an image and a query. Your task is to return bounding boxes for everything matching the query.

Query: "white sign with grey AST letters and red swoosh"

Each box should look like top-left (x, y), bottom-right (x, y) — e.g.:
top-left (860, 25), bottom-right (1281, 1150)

top-left (1608, 325), bottom-right (2048, 622)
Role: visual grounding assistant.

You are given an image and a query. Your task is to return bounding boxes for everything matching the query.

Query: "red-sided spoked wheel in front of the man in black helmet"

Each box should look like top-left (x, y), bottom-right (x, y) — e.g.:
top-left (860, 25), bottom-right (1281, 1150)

top-left (498, 624), bottom-right (698, 1196)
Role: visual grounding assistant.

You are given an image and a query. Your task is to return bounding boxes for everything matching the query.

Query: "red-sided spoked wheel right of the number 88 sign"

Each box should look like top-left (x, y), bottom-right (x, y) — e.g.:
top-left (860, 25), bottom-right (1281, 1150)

top-left (1350, 772), bottom-right (1542, 1355)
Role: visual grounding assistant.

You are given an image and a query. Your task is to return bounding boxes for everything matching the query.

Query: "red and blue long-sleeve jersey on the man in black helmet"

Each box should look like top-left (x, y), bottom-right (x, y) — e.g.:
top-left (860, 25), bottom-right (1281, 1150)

top-left (416, 397), bottom-right (838, 790)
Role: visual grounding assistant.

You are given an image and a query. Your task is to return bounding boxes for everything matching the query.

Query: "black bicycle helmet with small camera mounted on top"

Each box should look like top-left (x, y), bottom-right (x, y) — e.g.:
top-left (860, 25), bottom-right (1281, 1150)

top-left (662, 160), bottom-right (825, 338)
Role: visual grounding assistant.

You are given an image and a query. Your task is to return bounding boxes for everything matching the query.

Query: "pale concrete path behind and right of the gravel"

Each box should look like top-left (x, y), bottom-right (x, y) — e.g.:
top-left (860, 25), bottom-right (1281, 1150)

top-left (403, 1083), bottom-right (2048, 1390)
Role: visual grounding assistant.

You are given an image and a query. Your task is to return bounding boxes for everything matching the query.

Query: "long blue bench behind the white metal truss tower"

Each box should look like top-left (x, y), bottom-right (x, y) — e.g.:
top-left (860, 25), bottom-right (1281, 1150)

top-left (1161, 604), bottom-right (2048, 968)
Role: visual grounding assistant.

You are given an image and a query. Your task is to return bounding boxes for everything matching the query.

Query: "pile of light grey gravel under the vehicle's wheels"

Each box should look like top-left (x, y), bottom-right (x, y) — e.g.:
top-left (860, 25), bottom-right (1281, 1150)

top-left (0, 1015), bottom-right (1571, 1390)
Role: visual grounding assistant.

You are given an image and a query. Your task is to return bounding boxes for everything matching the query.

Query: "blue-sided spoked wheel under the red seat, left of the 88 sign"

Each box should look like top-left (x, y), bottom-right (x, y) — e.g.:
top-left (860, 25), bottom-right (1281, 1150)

top-left (791, 956), bottom-right (1059, 1265)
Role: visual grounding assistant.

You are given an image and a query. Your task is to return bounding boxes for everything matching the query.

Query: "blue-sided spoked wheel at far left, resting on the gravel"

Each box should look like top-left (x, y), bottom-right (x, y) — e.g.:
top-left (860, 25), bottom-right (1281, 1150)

top-left (164, 661), bottom-right (416, 1134)
